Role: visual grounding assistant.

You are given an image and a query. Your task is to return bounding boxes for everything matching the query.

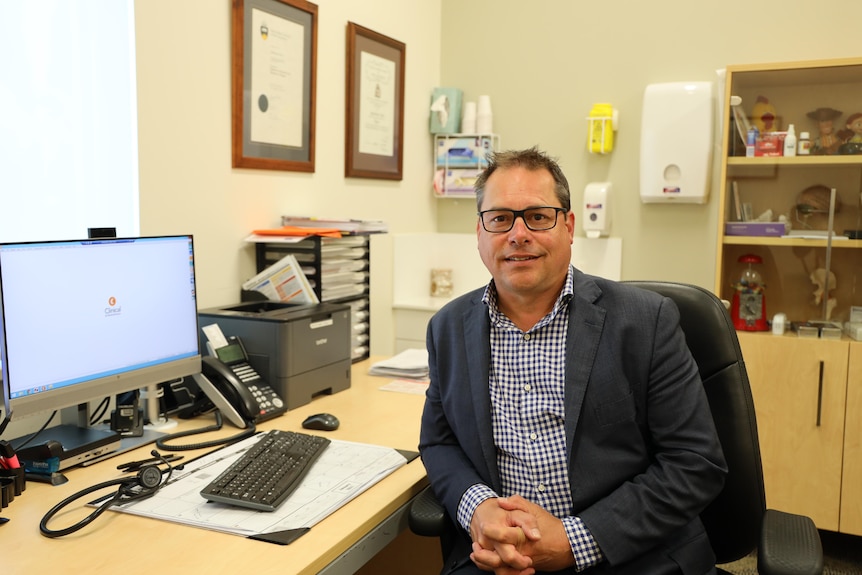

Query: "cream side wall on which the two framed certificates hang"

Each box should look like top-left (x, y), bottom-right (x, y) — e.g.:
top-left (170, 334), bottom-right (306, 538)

top-left (135, 0), bottom-right (441, 360)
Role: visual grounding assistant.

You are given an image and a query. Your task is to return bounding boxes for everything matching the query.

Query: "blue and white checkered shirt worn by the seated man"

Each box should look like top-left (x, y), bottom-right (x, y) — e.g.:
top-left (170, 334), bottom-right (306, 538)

top-left (458, 266), bottom-right (602, 571)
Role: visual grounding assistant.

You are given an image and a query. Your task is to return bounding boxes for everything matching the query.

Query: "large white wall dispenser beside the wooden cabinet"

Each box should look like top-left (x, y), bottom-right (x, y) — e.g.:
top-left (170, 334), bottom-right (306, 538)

top-left (640, 82), bottom-right (714, 204)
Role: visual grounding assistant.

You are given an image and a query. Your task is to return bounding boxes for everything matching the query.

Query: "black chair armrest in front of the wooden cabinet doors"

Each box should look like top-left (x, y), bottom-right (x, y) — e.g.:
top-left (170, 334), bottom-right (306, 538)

top-left (757, 509), bottom-right (823, 575)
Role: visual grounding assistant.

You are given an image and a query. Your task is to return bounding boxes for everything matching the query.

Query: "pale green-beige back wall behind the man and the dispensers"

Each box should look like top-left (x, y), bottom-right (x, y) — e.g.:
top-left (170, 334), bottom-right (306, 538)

top-left (437, 0), bottom-right (862, 290)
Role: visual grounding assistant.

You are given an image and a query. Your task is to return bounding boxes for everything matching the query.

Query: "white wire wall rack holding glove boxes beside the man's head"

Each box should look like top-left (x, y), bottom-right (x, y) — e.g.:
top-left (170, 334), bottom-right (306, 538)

top-left (432, 134), bottom-right (500, 198)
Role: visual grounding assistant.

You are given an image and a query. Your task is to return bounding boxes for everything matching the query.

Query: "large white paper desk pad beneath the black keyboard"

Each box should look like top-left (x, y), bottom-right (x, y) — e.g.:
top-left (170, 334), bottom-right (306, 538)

top-left (111, 434), bottom-right (407, 537)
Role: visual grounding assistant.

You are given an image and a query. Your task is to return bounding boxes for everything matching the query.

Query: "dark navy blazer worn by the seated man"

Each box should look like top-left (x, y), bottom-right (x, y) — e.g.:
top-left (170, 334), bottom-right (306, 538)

top-left (419, 269), bottom-right (726, 575)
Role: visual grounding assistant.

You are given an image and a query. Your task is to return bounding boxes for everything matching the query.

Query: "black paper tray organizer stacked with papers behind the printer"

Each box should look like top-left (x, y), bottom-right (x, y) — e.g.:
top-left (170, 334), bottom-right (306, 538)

top-left (250, 234), bottom-right (371, 363)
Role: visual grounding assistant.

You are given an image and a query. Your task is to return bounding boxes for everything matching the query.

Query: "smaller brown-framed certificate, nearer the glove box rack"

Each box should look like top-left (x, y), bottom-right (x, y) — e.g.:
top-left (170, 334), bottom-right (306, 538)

top-left (344, 22), bottom-right (406, 180)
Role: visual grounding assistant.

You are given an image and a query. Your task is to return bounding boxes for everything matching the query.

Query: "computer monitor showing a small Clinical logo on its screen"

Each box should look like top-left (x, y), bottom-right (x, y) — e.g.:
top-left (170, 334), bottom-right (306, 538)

top-left (0, 235), bottom-right (200, 419)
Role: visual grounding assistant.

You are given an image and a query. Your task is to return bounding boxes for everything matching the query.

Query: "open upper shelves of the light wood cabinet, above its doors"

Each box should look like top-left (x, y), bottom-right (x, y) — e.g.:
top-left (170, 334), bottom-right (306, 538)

top-left (715, 59), bottom-right (862, 321)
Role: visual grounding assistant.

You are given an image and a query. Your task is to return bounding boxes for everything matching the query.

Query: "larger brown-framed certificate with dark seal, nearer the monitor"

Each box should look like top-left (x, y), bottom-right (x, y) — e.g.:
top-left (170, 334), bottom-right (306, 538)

top-left (231, 0), bottom-right (318, 172)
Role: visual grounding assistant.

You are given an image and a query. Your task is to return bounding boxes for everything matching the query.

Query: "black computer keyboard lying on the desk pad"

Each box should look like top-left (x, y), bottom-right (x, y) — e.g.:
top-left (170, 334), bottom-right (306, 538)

top-left (201, 430), bottom-right (330, 511)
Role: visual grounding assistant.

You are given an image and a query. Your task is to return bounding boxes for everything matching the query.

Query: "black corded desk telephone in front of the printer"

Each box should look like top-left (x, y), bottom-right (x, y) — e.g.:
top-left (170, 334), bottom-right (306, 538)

top-left (197, 337), bottom-right (287, 428)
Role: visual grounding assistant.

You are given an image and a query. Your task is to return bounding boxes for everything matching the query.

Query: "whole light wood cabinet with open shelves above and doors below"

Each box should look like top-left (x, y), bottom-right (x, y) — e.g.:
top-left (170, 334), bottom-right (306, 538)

top-left (715, 59), bottom-right (862, 535)
